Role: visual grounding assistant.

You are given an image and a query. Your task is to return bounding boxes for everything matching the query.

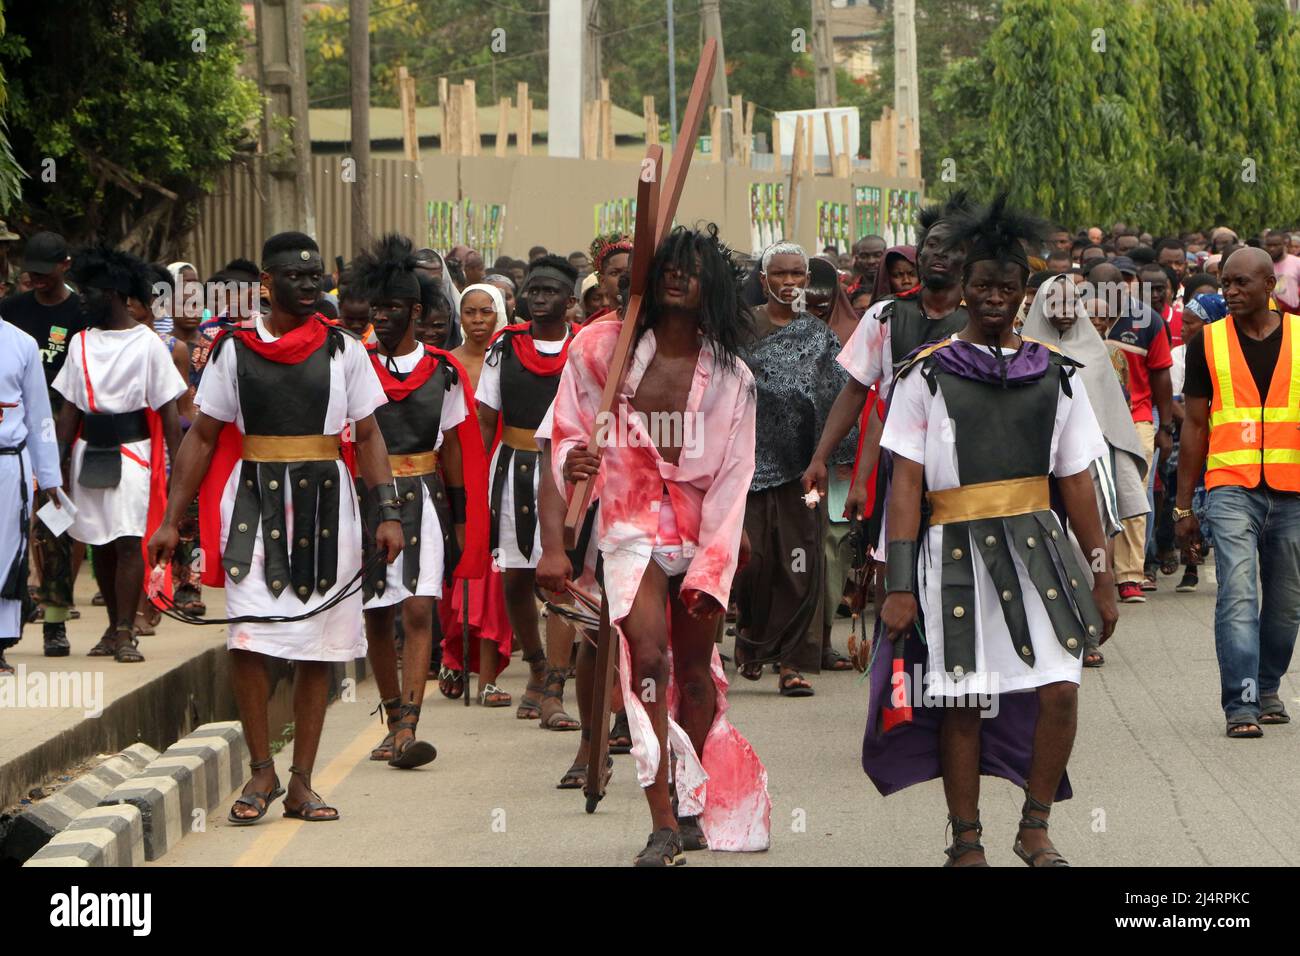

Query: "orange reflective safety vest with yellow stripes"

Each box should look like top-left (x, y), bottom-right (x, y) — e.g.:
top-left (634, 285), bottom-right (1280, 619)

top-left (1204, 315), bottom-right (1300, 492)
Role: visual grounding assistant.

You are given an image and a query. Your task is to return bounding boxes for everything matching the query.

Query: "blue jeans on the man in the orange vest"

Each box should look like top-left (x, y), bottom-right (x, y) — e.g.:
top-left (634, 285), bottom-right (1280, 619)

top-left (1209, 485), bottom-right (1300, 719)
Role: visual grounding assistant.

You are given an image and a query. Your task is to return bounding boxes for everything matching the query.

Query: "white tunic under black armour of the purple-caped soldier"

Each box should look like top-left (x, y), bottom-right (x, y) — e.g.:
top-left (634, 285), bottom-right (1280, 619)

top-left (880, 346), bottom-right (1106, 697)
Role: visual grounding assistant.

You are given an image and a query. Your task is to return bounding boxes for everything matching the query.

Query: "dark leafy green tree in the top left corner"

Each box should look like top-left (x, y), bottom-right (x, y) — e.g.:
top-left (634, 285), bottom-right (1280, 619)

top-left (0, 0), bottom-right (259, 258)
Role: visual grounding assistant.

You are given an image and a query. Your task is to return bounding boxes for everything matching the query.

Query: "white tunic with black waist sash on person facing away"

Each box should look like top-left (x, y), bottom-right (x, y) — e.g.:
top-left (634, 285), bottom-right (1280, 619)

top-left (53, 325), bottom-right (187, 545)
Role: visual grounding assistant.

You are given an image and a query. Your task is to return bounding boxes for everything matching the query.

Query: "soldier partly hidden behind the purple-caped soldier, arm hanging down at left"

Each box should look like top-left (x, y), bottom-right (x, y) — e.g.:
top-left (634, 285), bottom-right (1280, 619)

top-left (803, 193), bottom-right (971, 542)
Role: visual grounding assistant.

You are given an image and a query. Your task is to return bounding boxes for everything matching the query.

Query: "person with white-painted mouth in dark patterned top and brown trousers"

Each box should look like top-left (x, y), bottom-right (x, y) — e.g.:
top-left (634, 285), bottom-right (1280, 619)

top-left (733, 242), bottom-right (853, 697)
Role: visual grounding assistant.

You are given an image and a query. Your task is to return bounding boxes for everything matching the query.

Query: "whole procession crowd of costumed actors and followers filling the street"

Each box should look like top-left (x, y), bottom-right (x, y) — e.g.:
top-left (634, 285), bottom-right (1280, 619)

top-left (0, 200), bottom-right (1300, 865)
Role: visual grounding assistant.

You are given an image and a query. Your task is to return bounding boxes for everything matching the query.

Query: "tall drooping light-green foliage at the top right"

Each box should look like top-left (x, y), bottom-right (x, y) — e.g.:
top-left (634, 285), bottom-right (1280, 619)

top-left (923, 0), bottom-right (1300, 234)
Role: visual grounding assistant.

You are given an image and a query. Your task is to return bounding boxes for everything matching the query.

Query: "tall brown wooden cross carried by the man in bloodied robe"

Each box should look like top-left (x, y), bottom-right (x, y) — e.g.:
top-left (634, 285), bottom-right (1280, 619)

top-left (564, 39), bottom-right (718, 813)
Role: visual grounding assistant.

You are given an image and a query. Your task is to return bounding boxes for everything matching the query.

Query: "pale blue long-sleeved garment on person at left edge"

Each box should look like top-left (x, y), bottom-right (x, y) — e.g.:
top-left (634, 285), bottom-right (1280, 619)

top-left (0, 320), bottom-right (62, 637)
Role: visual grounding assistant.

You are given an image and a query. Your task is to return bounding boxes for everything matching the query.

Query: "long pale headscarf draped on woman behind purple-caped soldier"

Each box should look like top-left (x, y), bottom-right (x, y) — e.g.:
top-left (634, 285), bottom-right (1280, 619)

top-left (1022, 276), bottom-right (1147, 476)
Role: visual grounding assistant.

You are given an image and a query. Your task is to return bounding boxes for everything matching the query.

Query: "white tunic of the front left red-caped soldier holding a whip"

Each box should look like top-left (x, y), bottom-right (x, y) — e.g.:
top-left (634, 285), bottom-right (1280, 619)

top-left (195, 316), bottom-right (387, 661)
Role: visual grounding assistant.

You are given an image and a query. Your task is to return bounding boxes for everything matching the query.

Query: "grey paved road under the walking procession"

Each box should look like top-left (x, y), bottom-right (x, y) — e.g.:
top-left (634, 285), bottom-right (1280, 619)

top-left (160, 561), bottom-right (1300, 866)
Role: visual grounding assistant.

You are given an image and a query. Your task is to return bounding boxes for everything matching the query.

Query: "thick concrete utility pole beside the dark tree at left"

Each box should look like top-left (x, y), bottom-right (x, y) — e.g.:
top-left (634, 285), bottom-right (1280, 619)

top-left (254, 0), bottom-right (316, 235)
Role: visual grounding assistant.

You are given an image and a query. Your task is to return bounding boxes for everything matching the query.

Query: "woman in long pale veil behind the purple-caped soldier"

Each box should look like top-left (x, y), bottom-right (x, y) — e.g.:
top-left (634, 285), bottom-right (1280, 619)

top-left (1022, 276), bottom-right (1149, 667)
